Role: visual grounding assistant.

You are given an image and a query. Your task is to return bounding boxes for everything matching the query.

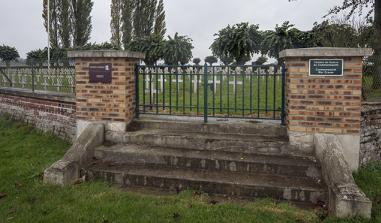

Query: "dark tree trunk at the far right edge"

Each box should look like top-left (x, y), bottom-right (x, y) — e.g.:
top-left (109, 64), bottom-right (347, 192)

top-left (373, 0), bottom-right (381, 90)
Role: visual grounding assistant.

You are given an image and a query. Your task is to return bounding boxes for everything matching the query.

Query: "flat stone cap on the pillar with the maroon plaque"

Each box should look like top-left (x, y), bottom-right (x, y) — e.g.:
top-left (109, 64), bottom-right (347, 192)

top-left (67, 50), bottom-right (145, 59)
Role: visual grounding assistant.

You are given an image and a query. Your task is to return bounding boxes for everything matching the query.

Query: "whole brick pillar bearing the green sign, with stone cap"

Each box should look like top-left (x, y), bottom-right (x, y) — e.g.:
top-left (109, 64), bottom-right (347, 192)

top-left (280, 48), bottom-right (372, 169)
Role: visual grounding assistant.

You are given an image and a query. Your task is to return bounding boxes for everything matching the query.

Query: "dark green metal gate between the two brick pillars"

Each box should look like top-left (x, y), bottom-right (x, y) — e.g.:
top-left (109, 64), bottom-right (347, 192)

top-left (135, 65), bottom-right (285, 121)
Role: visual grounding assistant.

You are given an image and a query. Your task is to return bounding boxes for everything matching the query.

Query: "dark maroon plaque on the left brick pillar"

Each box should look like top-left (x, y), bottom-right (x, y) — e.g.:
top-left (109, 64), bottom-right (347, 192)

top-left (89, 63), bottom-right (112, 84)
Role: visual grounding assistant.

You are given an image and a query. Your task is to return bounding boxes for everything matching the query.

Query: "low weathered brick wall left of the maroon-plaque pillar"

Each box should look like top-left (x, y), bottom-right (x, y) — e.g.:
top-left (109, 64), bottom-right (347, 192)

top-left (0, 88), bottom-right (76, 140)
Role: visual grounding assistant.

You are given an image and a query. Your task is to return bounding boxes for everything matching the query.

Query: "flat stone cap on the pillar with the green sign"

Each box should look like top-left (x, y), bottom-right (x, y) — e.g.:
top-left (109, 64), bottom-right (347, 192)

top-left (279, 47), bottom-right (373, 58)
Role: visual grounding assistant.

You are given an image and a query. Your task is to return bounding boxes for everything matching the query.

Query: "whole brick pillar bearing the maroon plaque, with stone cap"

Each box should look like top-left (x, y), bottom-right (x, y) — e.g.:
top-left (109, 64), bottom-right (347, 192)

top-left (68, 50), bottom-right (144, 136)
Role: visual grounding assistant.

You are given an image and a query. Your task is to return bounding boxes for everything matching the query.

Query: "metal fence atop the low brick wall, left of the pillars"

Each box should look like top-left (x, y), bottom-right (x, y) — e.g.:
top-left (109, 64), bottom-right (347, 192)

top-left (0, 65), bottom-right (75, 93)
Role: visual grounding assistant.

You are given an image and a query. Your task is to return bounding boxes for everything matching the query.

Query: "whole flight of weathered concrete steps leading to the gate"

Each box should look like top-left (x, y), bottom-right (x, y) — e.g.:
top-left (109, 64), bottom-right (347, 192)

top-left (86, 118), bottom-right (327, 204)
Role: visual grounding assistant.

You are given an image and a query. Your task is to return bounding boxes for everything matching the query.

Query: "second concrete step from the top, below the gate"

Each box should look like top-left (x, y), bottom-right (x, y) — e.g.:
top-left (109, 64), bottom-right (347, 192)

top-left (106, 129), bottom-right (300, 155)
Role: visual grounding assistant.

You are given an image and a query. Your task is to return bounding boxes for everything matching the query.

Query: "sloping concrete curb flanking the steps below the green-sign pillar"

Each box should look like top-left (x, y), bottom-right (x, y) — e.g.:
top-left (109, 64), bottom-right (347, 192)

top-left (314, 134), bottom-right (372, 218)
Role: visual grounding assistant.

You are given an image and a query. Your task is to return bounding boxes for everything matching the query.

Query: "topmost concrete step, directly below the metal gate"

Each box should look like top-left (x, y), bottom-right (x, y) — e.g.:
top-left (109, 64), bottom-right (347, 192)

top-left (127, 118), bottom-right (287, 138)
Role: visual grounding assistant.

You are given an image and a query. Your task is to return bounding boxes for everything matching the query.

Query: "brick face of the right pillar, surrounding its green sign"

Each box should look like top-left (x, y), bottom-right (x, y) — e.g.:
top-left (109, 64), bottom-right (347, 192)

top-left (286, 57), bottom-right (362, 134)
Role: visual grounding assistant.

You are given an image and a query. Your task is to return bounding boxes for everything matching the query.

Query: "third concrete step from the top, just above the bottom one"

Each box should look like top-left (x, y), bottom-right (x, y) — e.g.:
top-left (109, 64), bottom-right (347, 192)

top-left (95, 144), bottom-right (321, 182)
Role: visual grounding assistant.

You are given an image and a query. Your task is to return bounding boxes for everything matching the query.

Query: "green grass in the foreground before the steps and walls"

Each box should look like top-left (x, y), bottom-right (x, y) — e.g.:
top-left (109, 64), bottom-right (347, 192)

top-left (0, 117), bottom-right (381, 223)
